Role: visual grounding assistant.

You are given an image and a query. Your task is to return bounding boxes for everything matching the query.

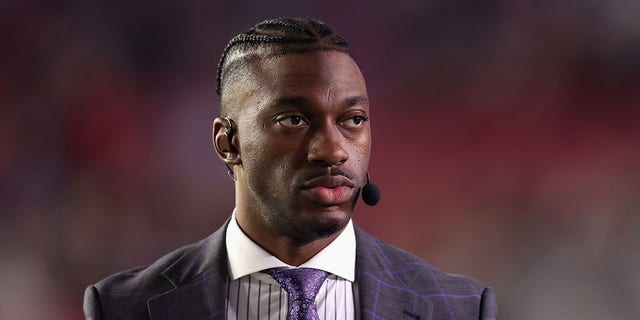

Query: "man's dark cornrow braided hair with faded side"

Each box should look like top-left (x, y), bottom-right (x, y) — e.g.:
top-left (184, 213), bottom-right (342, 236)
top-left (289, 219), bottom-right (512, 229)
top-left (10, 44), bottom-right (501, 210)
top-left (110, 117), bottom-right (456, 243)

top-left (216, 18), bottom-right (351, 97)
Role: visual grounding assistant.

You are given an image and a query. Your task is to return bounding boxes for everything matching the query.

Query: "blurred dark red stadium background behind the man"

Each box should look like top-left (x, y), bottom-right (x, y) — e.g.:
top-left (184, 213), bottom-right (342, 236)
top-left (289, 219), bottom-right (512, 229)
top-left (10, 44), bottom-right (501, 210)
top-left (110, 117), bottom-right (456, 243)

top-left (0, 0), bottom-right (640, 319)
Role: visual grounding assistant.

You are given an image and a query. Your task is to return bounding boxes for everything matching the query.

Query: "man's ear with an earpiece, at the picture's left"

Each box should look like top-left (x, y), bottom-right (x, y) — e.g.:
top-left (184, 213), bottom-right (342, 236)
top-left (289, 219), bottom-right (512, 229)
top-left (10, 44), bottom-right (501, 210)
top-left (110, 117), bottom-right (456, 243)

top-left (212, 118), bottom-right (242, 166)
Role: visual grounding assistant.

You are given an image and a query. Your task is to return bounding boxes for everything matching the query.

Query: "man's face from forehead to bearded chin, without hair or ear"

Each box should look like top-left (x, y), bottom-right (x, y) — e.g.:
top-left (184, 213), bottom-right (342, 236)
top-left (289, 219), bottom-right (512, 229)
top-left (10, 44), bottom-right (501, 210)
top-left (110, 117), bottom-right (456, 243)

top-left (229, 51), bottom-right (371, 243)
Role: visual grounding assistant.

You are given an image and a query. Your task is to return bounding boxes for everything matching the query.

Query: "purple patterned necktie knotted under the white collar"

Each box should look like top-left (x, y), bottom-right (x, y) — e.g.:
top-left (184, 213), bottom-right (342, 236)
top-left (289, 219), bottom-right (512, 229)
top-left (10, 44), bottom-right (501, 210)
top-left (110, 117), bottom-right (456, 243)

top-left (264, 268), bottom-right (329, 320)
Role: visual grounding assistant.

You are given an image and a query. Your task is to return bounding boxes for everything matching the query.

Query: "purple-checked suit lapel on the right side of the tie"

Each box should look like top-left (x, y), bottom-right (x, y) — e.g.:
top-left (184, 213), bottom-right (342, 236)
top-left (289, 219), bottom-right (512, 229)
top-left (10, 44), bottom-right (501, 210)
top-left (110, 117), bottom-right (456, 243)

top-left (355, 226), bottom-right (433, 320)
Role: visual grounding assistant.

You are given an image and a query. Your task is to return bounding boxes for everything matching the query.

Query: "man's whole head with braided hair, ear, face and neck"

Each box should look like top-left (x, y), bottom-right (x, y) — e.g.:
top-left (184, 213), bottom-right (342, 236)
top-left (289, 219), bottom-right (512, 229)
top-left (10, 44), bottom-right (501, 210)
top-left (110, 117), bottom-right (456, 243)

top-left (213, 19), bottom-right (371, 258)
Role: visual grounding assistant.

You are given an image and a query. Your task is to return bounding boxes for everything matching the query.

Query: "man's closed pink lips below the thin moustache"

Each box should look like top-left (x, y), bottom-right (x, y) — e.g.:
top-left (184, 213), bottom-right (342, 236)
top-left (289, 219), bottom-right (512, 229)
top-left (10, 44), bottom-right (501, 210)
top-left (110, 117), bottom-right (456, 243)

top-left (302, 175), bottom-right (355, 205)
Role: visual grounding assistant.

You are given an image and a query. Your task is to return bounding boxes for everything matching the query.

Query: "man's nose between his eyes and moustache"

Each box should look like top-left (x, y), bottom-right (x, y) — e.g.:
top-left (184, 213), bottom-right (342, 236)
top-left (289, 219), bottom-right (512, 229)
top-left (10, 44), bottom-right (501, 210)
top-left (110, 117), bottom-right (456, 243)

top-left (307, 123), bottom-right (349, 167)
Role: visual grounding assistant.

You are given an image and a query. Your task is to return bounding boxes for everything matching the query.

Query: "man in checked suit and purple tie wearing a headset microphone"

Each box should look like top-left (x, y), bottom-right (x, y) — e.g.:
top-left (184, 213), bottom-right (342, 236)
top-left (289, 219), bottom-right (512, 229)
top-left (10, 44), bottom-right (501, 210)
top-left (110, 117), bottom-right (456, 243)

top-left (84, 19), bottom-right (497, 320)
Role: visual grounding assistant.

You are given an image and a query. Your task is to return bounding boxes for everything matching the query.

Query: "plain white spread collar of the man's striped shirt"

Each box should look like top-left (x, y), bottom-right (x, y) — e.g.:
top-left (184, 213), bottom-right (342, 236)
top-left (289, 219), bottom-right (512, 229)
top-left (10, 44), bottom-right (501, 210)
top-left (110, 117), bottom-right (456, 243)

top-left (226, 210), bottom-right (356, 282)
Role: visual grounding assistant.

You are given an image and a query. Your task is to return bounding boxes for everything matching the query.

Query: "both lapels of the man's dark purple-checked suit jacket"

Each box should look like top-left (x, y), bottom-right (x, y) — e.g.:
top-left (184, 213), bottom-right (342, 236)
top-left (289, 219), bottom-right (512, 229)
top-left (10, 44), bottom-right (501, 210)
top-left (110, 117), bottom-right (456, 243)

top-left (148, 221), bottom-right (433, 320)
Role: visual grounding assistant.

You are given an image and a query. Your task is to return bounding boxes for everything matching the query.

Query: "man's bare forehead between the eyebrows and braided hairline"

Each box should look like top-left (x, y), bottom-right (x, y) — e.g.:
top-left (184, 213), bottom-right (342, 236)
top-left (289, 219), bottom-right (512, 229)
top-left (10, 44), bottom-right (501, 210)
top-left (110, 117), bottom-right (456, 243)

top-left (223, 50), bottom-right (366, 111)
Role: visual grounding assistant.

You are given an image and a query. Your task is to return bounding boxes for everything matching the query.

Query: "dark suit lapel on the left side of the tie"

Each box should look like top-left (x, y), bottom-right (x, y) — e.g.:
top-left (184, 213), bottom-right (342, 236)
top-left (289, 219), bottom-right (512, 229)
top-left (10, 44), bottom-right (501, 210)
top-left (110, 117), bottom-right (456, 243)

top-left (148, 223), bottom-right (229, 320)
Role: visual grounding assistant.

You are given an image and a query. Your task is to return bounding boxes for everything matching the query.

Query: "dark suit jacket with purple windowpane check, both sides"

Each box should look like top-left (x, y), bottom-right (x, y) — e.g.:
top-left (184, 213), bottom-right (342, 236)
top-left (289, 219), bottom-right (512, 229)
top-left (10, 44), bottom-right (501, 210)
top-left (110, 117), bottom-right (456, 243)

top-left (84, 225), bottom-right (497, 320)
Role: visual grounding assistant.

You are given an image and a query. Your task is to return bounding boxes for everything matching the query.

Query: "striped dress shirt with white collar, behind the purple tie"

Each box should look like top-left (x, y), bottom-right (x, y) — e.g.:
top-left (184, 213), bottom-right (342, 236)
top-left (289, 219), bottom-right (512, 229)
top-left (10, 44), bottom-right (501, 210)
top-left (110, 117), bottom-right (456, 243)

top-left (226, 210), bottom-right (356, 320)
